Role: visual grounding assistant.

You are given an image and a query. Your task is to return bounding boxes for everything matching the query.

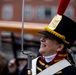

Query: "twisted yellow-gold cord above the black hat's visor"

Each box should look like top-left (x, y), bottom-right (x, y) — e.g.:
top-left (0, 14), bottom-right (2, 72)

top-left (45, 26), bottom-right (69, 44)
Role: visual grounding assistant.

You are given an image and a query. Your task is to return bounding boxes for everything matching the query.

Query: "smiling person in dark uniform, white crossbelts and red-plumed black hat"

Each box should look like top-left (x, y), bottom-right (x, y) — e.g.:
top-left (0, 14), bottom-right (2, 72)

top-left (19, 0), bottom-right (76, 75)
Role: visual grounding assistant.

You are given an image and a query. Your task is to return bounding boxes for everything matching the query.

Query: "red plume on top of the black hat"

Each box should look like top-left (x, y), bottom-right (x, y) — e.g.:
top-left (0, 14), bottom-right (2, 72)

top-left (57, 0), bottom-right (70, 15)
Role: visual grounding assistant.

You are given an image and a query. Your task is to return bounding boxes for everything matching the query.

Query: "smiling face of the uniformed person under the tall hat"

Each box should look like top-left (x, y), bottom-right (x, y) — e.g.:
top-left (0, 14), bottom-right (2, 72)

top-left (39, 36), bottom-right (59, 56)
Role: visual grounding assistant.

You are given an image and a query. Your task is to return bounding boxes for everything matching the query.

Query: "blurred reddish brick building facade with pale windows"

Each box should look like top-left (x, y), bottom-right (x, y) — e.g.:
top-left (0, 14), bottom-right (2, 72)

top-left (0, 0), bottom-right (76, 23)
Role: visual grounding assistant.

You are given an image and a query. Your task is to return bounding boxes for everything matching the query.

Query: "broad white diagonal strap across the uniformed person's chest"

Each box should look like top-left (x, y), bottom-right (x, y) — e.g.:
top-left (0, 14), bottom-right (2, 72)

top-left (37, 59), bottom-right (71, 75)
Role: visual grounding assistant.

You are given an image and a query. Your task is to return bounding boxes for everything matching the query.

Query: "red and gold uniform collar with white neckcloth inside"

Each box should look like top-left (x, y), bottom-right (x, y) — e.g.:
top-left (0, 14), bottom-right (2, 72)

top-left (40, 51), bottom-right (67, 65)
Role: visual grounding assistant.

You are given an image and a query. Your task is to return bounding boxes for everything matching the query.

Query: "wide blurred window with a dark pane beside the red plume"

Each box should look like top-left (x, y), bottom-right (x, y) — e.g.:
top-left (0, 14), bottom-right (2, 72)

top-left (36, 6), bottom-right (56, 20)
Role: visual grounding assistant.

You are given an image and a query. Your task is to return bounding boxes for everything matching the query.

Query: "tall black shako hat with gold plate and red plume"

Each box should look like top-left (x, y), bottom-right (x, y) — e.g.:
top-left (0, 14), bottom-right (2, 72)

top-left (39, 0), bottom-right (76, 48)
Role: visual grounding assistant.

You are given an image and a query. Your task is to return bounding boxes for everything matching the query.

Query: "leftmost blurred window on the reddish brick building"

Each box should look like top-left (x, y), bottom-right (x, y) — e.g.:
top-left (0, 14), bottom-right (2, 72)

top-left (2, 4), bottom-right (13, 20)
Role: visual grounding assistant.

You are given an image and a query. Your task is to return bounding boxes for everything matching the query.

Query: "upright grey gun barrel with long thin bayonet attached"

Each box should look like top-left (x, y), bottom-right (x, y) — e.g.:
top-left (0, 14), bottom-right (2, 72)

top-left (21, 0), bottom-right (32, 75)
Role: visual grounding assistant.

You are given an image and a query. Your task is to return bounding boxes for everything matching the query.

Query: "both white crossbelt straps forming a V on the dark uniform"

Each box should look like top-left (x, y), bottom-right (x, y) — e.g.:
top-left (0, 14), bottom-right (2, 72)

top-left (32, 58), bottom-right (71, 75)
